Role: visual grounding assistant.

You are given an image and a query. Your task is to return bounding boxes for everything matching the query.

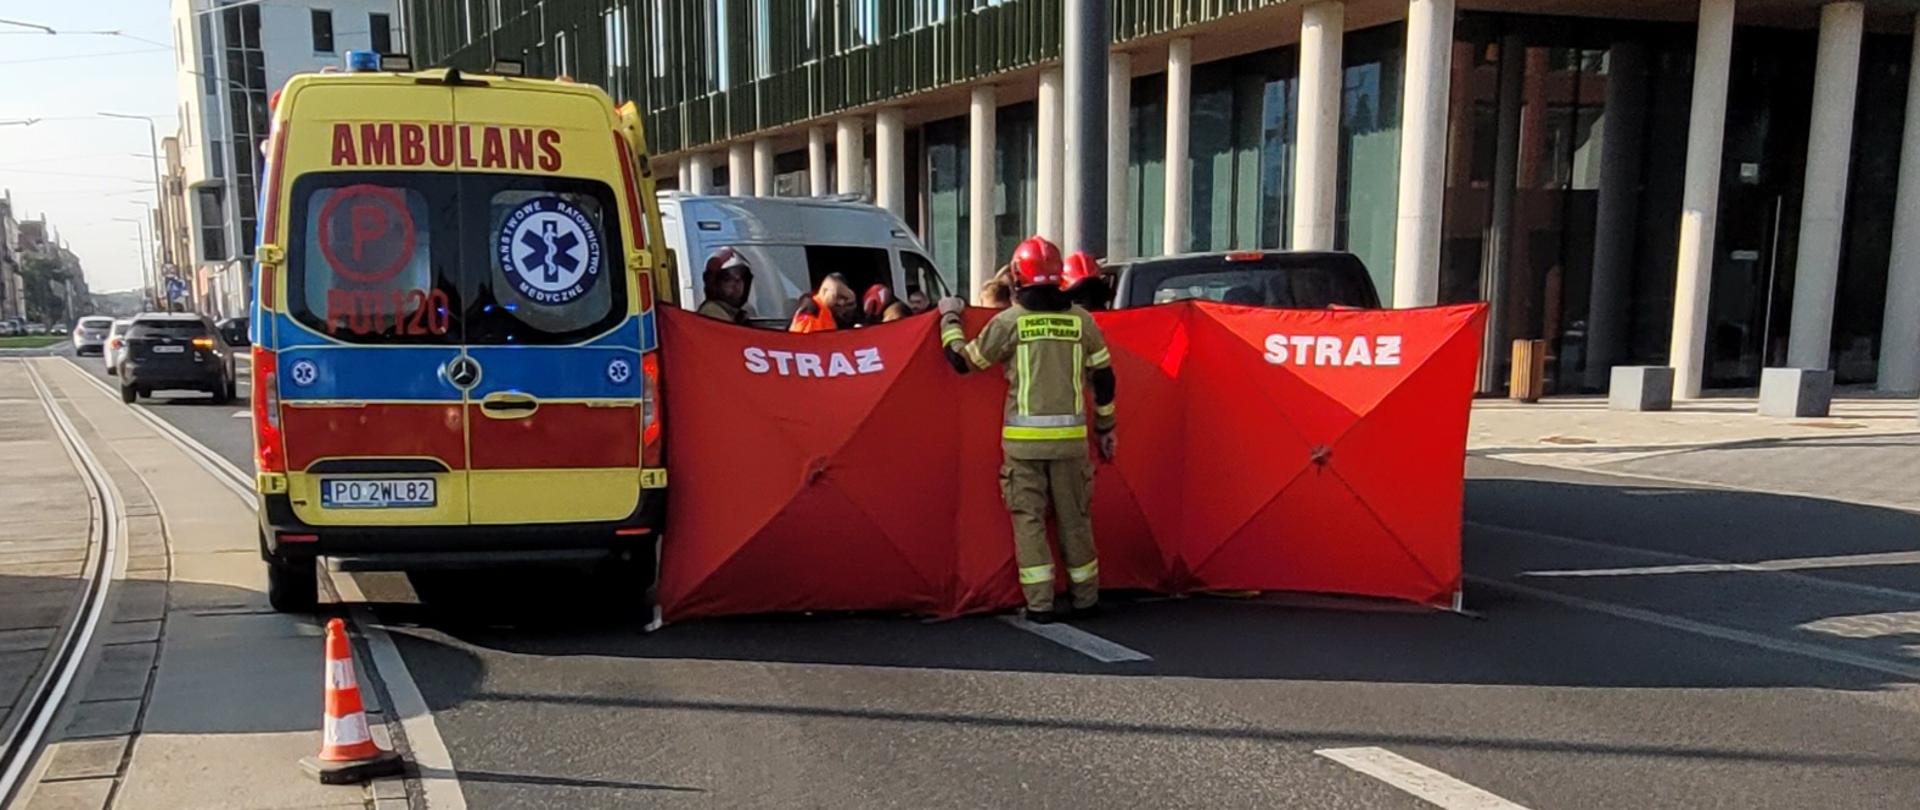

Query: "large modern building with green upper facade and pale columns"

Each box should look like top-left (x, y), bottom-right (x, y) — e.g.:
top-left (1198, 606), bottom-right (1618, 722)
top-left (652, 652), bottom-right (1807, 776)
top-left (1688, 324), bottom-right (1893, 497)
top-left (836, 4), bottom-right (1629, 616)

top-left (403, 0), bottom-right (1920, 395)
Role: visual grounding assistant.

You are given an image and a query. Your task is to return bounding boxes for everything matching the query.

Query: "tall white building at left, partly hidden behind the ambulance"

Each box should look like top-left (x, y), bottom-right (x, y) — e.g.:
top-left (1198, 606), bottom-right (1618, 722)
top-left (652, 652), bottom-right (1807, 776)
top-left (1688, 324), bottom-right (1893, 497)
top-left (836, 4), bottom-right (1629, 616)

top-left (173, 0), bottom-right (403, 313)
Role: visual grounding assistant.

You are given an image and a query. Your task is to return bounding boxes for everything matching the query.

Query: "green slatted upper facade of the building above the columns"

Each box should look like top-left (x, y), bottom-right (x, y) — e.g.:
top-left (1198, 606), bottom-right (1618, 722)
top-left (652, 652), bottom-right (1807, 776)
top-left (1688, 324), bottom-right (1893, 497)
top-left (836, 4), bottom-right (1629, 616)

top-left (403, 0), bottom-right (1288, 152)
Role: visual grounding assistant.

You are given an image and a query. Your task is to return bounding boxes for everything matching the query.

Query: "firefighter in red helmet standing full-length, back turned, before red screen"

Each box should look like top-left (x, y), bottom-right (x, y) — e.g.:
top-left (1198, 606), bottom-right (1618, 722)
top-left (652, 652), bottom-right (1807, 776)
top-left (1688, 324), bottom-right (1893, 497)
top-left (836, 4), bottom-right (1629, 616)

top-left (941, 236), bottom-right (1116, 624)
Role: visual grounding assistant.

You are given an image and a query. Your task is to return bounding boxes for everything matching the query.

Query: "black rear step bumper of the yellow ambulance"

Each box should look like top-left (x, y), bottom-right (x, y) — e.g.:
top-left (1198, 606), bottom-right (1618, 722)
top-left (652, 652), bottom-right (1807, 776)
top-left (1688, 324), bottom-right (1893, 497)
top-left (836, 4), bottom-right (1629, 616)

top-left (259, 489), bottom-right (666, 570)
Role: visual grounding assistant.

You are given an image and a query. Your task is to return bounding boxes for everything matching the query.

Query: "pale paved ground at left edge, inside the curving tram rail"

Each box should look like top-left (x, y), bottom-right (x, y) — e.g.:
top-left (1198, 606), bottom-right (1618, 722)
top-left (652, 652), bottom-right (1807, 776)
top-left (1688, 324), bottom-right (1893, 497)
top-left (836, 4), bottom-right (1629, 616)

top-left (0, 359), bottom-right (92, 763)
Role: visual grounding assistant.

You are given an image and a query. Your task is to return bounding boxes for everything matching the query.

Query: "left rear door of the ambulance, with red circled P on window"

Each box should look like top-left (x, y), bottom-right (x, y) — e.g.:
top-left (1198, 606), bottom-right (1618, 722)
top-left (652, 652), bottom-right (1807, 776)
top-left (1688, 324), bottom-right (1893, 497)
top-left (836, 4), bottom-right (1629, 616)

top-left (274, 83), bottom-right (470, 526)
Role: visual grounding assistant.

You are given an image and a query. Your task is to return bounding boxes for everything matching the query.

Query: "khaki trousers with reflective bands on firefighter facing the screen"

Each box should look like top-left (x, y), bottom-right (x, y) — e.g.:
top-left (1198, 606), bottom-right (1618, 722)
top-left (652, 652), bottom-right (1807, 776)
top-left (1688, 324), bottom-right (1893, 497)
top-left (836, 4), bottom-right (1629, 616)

top-left (1000, 457), bottom-right (1100, 612)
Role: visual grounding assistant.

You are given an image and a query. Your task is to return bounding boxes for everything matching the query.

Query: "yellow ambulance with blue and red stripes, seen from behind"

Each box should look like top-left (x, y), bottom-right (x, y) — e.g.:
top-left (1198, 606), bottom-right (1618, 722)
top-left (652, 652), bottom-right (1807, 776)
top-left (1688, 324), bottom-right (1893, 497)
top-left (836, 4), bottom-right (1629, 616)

top-left (252, 52), bottom-right (674, 612)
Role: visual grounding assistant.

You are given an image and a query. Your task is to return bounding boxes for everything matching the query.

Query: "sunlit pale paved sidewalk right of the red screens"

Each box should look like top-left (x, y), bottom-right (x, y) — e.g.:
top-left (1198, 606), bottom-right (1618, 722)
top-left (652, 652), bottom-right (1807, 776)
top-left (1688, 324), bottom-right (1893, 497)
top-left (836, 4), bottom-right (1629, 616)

top-left (1467, 397), bottom-right (1920, 511)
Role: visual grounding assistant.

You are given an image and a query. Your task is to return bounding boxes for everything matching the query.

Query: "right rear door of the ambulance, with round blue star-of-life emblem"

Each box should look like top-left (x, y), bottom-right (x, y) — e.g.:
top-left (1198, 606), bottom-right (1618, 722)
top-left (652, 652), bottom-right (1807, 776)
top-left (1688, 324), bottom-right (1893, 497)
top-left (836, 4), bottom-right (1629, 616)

top-left (453, 86), bottom-right (653, 524)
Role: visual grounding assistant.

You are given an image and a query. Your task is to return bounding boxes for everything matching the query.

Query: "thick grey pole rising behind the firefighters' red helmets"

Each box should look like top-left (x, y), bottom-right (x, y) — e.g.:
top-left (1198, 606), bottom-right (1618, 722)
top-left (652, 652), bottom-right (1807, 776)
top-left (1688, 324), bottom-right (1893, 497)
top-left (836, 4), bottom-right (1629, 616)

top-left (1060, 0), bottom-right (1127, 255)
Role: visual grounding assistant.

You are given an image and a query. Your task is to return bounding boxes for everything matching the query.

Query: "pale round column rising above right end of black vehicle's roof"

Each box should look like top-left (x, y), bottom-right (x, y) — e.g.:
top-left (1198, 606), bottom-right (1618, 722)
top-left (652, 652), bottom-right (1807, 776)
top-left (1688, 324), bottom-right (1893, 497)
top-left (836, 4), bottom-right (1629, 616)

top-left (1294, 0), bottom-right (1346, 250)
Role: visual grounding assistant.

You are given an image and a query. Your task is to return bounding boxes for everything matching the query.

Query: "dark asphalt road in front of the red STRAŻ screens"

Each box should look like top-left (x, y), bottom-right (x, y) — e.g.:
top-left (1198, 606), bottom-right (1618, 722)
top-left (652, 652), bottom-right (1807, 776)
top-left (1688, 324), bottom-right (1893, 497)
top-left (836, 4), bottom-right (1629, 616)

top-left (83, 347), bottom-right (1920, 810)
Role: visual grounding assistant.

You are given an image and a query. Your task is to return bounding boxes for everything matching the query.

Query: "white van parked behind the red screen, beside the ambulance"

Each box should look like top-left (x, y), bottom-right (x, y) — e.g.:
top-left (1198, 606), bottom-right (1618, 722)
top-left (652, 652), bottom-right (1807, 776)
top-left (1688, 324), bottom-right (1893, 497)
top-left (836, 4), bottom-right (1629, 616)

top-left (659, 192), bottom-right (950, 328)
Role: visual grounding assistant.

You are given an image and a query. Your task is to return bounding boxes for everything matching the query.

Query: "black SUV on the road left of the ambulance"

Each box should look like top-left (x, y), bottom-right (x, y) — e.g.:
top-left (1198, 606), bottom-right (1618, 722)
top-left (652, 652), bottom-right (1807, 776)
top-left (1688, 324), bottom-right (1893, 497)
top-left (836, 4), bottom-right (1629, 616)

top-left (119, 313), bottom-right (234, 403)
